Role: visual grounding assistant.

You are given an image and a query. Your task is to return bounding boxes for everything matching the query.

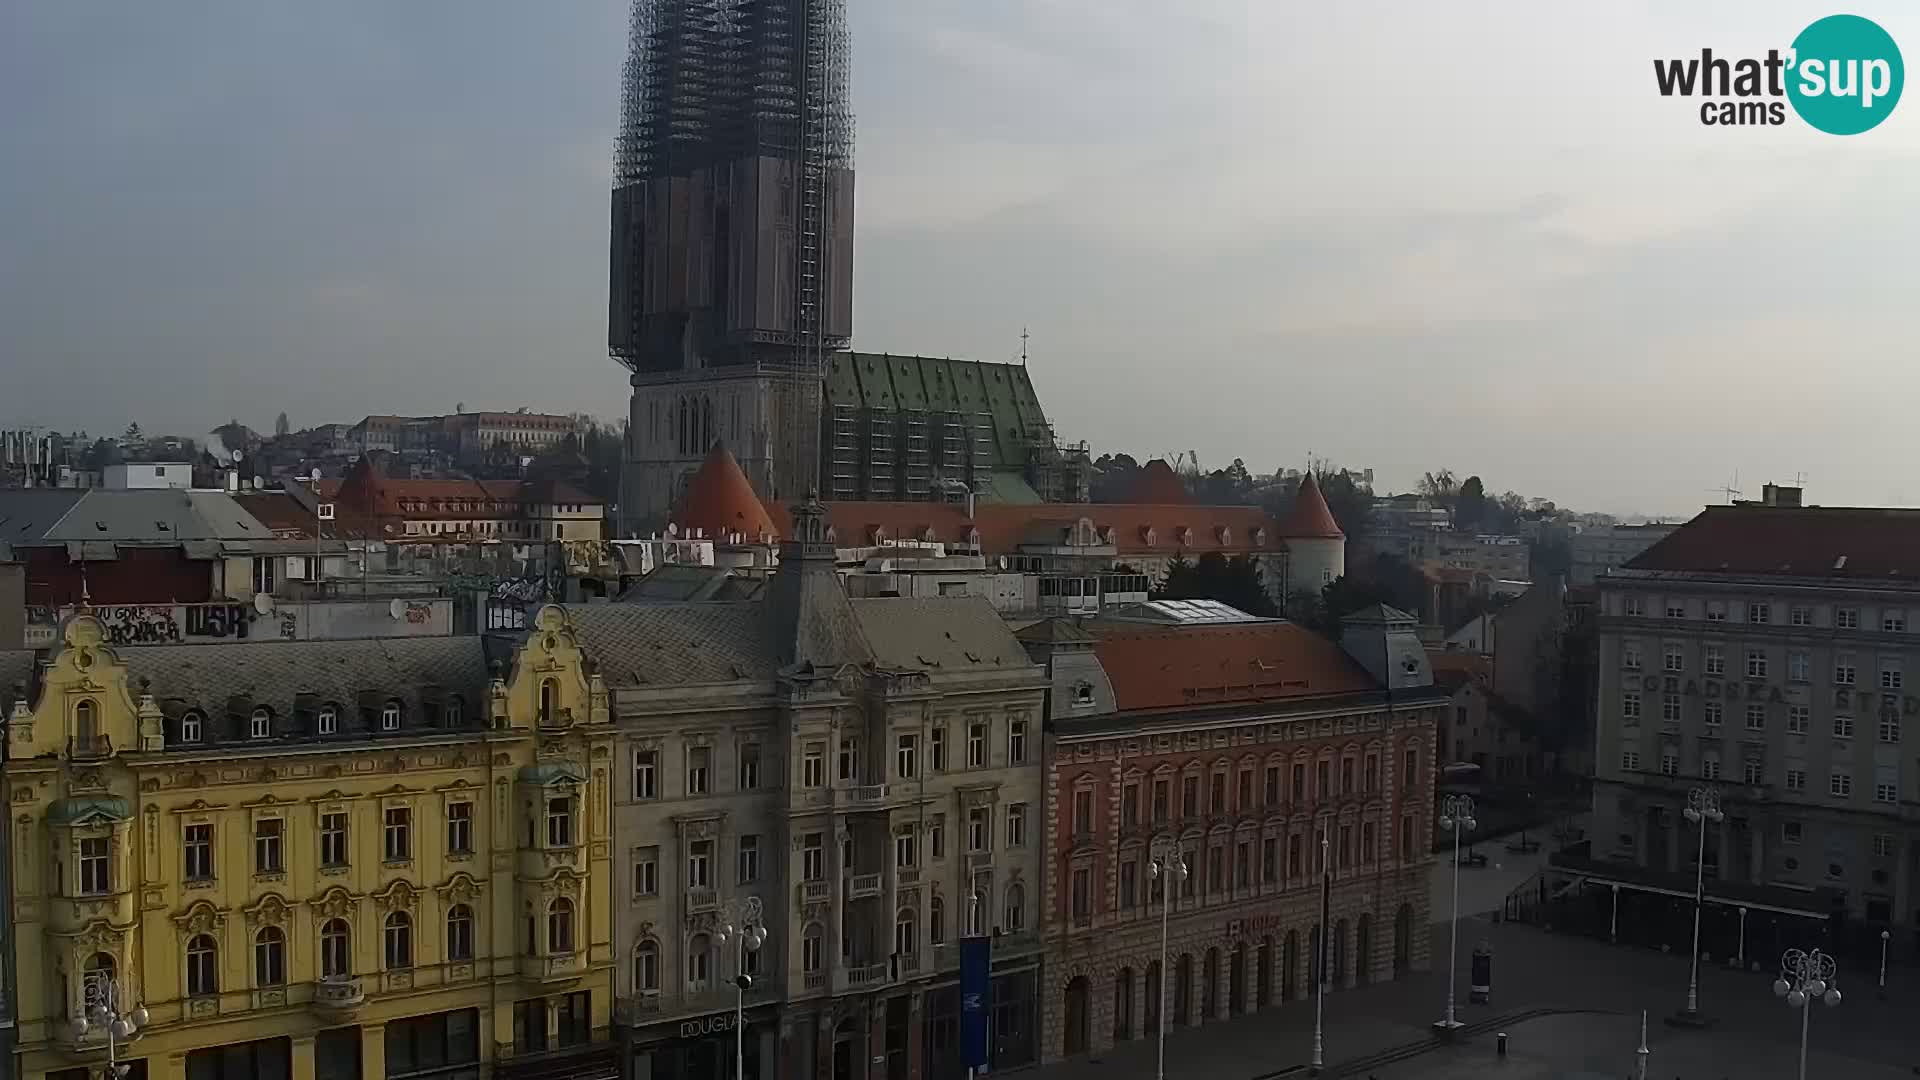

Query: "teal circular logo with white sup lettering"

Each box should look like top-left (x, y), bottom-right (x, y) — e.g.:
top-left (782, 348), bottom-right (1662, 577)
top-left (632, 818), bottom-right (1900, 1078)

top-left (1788, 15), bottom-right (1907, 135)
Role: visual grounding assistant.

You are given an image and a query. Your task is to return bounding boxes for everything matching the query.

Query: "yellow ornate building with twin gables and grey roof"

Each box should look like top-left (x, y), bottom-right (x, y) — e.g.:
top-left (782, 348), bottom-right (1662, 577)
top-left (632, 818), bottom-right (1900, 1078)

top-left (0, 607), bottom-right (618, 1080)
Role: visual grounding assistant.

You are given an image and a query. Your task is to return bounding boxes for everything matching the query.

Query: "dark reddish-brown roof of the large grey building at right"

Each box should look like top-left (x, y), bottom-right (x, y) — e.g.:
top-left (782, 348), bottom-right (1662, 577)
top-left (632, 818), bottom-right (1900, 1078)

top-left (1626, 505), bottom-right (1920, 582)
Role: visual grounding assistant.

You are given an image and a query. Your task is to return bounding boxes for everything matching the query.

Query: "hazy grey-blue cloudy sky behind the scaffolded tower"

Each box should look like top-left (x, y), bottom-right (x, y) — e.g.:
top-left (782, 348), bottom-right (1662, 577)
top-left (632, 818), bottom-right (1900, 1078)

top-left (0, 0), bottom-right (1920, 513)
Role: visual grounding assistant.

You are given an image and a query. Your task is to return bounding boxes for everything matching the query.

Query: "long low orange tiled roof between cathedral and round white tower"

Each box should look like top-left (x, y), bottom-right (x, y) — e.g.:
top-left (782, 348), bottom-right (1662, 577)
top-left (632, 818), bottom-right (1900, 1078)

top-left (766, 502), bottom-right (1281, 559)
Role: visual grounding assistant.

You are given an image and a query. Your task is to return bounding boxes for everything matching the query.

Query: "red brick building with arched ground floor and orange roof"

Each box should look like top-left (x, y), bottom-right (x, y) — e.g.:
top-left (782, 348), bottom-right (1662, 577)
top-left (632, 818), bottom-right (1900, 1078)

top-left (1029, 607), bottom-right (1446, 1059)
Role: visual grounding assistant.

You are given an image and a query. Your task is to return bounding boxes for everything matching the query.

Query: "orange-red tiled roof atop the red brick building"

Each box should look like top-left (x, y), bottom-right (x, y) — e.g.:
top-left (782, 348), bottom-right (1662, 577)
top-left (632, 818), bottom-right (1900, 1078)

top-left (1087, 623), bottom-right (1377, 711)
